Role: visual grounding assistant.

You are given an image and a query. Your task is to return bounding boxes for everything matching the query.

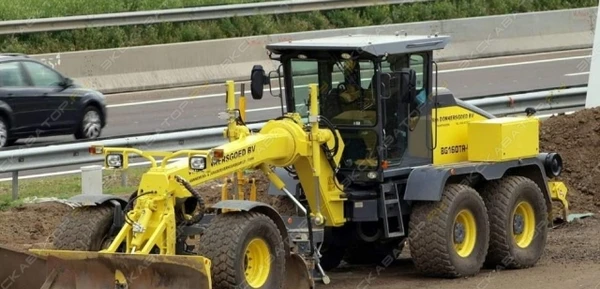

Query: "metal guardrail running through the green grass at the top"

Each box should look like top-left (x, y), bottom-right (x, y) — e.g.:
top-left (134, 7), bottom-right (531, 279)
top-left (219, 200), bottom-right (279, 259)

top-left (0, 0), bottom-right (434, 34)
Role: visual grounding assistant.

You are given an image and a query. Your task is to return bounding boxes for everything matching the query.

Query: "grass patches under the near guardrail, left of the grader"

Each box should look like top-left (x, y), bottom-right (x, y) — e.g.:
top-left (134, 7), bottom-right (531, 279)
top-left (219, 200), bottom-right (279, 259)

top-left (0, 167), bottom-right (148, 210)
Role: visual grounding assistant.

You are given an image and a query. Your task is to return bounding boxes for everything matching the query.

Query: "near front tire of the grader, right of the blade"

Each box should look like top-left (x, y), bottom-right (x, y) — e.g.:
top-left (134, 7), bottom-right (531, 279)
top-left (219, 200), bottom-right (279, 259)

top-left (198, 212), bottom-right (286, 289)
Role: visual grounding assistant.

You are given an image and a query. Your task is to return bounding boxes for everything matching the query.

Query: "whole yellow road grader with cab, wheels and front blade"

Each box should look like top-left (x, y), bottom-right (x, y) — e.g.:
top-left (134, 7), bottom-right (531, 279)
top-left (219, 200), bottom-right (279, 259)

top-left (9, 35), bottom-right (567, 289)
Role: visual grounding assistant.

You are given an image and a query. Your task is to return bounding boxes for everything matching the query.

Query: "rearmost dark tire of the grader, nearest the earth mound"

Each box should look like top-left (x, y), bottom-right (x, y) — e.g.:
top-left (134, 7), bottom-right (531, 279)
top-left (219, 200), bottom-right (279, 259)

top-left (482, 176), bottom-right (548, 269)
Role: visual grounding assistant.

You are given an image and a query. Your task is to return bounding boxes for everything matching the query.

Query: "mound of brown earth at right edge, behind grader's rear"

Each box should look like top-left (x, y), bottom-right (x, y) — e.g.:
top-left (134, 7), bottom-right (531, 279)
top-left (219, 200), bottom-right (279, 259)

top-left (540, 108), bottom-right (600, 213)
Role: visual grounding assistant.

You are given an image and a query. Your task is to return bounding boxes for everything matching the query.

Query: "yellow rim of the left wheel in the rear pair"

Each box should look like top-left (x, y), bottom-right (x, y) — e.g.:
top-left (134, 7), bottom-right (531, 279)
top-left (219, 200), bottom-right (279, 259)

top-left (453, 210), bottom-right (477, 258)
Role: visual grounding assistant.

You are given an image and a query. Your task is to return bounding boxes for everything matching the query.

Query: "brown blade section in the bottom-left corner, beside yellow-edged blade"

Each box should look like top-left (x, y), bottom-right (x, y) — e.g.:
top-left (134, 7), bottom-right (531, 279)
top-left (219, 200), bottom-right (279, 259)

top-left (0, 246), bottom-right (46, 289)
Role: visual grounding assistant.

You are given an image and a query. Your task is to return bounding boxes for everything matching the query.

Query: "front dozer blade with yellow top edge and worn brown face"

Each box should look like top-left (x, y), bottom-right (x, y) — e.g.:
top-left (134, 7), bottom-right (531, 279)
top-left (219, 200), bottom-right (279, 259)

top-left (32, 250), bottom-right (211, 289)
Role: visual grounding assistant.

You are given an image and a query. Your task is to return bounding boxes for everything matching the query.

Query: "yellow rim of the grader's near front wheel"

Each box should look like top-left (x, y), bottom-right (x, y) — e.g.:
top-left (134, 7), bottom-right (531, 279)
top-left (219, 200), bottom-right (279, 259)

top-left (244, 238), bottom-right (271, 288)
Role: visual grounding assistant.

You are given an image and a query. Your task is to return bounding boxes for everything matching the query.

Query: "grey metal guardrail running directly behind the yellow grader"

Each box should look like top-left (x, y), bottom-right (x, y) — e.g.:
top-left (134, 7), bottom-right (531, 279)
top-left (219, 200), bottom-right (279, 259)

top-left (0, 87), bottom-right (587, 199)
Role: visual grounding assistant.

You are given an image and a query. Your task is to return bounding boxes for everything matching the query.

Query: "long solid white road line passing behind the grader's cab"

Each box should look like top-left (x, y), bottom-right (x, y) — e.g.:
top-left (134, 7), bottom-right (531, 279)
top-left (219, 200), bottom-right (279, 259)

top-left (107, 55), bottom-right (592, 111)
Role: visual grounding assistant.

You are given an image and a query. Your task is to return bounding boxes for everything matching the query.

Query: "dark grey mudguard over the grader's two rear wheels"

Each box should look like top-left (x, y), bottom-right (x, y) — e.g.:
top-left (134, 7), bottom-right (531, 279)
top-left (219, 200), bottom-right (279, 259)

top-left (404, 157), bottom-right (550, 202)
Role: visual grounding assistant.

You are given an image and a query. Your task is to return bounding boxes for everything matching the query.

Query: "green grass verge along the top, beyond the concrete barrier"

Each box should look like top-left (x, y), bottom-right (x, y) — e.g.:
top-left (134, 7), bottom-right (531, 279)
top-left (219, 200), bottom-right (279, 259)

top-left (0, 0), bottom-right (598, 54)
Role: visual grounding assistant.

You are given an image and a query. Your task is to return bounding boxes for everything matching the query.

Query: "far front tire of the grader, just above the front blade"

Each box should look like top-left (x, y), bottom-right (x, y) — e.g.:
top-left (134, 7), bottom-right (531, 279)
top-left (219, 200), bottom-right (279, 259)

top-left (52, 206), bottom-right (114, 251)
